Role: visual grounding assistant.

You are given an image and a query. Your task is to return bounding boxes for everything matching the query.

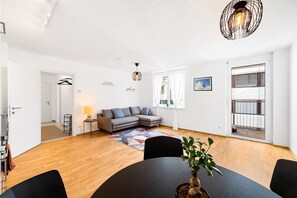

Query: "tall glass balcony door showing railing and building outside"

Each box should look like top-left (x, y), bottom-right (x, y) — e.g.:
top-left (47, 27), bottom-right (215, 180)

top-left (231, 64), bottom-right (266, 141)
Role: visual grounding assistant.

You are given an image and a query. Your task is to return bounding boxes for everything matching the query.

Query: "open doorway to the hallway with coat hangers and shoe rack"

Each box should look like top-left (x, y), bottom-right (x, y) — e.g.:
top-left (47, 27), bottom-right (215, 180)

top-left (41, 72), bottom-right (74, 141)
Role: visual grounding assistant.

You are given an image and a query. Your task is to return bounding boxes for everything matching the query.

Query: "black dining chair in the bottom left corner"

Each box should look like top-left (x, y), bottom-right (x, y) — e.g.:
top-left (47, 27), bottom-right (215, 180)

top-left (0, 170), bottom-right (67, 198)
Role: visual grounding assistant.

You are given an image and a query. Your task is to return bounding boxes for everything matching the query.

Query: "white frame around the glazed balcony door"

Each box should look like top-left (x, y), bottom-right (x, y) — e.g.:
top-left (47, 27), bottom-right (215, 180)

top-left (225, 54), bottom-right (273, 143)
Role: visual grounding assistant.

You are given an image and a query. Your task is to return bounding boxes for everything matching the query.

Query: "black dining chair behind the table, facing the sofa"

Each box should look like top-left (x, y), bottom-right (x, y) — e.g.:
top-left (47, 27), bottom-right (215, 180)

top-left (144, 136), bottom-right (183, 160)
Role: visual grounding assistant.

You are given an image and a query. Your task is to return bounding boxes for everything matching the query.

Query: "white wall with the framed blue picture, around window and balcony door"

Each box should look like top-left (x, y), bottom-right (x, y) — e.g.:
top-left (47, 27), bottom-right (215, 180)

top-left (141, 49), bottom-right (289, 146)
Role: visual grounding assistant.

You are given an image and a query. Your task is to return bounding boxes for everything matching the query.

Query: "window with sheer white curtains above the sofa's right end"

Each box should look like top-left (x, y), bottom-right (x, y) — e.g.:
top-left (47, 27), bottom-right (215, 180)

top-left (153, 69), bottom-right (185, 108)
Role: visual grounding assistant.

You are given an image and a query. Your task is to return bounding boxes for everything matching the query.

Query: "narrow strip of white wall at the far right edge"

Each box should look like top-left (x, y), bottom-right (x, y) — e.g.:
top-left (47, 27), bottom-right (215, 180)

top-left (290, 40), bottom-right (297, 155)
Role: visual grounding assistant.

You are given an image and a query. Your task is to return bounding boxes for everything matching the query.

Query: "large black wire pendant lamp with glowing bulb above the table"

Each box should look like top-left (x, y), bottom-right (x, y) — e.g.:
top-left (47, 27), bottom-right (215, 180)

top-left (220, 0), bottom-right (263, 40)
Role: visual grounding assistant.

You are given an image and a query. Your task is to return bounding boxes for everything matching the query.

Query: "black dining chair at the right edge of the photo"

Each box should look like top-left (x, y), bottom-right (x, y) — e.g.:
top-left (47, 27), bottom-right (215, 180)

top-left (270, 159), bottom-right (297, 198)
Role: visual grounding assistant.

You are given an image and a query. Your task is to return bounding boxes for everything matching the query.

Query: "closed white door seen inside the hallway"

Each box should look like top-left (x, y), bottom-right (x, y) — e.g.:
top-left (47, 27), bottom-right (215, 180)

top-left (41, 82), bottom-right (52, 122)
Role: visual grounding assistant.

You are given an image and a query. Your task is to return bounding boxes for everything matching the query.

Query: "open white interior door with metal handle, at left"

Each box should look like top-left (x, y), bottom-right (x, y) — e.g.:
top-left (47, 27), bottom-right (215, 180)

top-left (8, 62), bottom-right (41, 157)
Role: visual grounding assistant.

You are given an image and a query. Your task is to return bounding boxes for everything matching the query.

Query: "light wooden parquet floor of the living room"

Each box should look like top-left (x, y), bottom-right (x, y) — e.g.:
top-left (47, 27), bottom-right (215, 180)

top-left (6, 127), bottom-right (297, 198)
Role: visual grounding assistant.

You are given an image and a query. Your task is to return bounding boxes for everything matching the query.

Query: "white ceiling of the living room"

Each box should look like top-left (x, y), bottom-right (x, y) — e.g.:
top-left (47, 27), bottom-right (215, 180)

top-left (2, 0), bottom-right (297, 71)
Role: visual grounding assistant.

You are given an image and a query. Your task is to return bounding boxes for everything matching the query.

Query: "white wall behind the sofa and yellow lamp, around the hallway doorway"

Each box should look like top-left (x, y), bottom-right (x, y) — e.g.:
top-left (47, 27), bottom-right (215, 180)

top-left (8, 49), bottom-right (140, 134)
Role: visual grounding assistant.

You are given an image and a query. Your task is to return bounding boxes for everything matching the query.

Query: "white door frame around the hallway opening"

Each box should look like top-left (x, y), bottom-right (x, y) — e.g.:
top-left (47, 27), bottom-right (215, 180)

top-left (39, 68), bottom-right (79, 136)
